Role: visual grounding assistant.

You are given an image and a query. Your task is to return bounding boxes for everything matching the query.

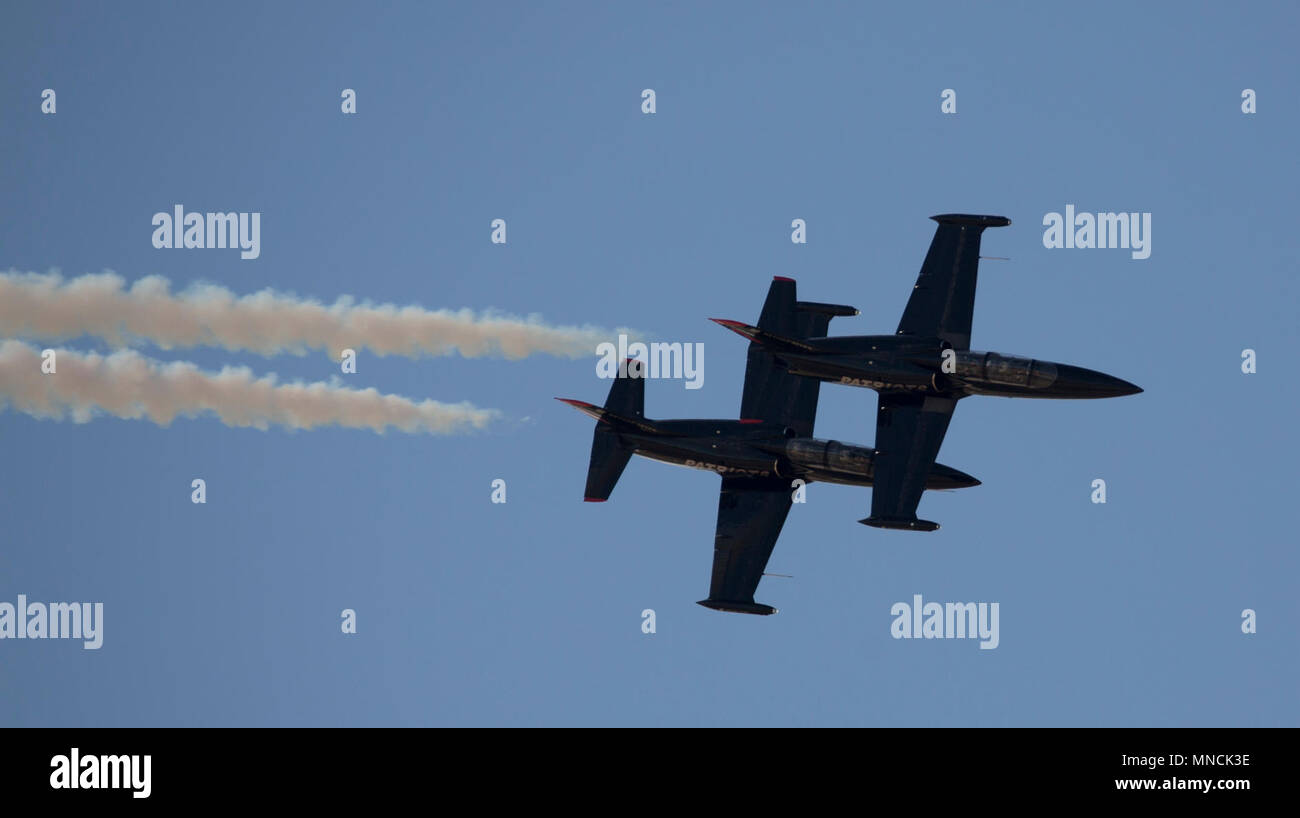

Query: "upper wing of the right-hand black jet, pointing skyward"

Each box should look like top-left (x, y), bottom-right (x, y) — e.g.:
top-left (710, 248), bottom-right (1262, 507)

top-left (898, 213), bottom-right (1011, 348)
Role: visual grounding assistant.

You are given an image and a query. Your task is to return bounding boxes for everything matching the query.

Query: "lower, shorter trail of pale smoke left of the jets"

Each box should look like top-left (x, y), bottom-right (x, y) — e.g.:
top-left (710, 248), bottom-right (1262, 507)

top-left (0, 341), bottom-right (498, 434)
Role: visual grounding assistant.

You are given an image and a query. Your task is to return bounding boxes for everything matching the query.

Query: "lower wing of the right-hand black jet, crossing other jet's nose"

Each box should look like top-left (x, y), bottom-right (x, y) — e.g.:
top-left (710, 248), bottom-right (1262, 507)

top-left (858, 393), bottom-right (957, 531)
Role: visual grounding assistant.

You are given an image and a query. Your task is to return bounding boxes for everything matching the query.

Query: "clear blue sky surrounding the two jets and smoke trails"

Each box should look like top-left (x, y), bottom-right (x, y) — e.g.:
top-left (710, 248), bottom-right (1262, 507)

top-left (0, 3), bottom-right (1300, 726)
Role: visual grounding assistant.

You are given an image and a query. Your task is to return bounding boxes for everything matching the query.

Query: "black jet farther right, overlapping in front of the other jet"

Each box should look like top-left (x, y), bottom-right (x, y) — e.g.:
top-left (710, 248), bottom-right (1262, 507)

top-left (714, 213), bottom-right (1141, 531)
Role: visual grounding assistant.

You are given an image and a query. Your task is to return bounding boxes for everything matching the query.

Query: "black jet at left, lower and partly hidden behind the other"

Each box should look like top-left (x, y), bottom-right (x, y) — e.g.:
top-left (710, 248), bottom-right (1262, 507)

top-left (556, 278), bottom-right (979, 614)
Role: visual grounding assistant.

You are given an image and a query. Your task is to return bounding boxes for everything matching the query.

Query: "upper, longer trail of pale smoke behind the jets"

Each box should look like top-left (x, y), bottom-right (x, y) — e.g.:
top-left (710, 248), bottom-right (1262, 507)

top-left (0, 269), bottom-right (629, 359)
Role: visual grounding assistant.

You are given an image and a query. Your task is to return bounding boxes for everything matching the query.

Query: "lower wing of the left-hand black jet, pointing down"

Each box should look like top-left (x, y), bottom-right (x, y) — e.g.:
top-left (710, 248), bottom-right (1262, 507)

top-left (699, 476), bottom-right (793, 614)
